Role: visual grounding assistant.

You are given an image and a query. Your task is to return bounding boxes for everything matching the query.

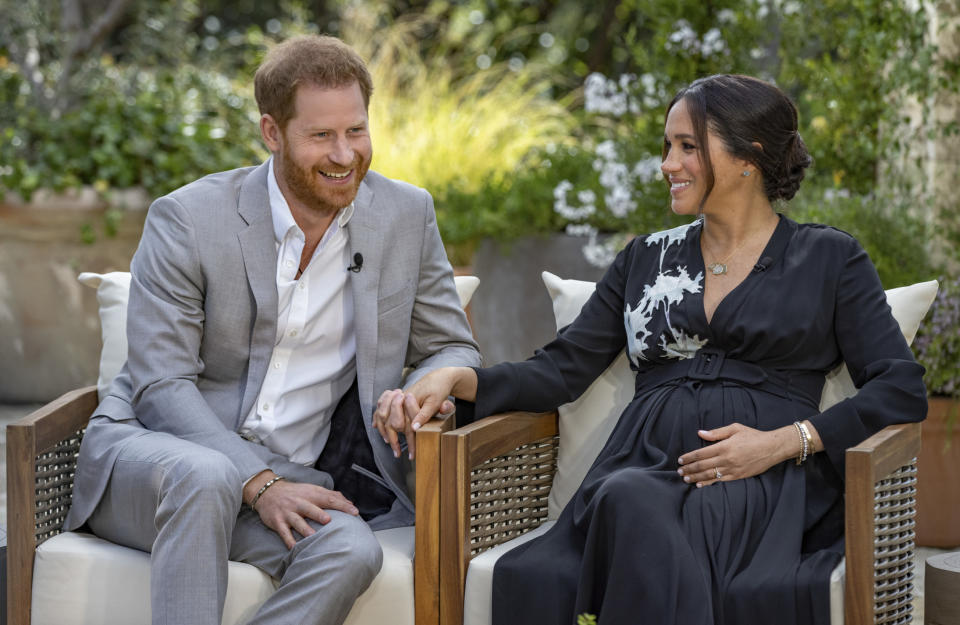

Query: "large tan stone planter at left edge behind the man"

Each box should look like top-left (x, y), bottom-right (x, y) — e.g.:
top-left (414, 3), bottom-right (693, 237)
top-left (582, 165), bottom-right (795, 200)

top-left (0, 198), bottom-right (146, 403)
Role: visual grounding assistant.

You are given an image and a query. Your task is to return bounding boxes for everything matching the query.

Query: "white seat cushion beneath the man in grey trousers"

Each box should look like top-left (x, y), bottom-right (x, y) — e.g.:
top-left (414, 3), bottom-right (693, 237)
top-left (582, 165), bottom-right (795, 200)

top-left (32, 527), bottom-right (414, 625)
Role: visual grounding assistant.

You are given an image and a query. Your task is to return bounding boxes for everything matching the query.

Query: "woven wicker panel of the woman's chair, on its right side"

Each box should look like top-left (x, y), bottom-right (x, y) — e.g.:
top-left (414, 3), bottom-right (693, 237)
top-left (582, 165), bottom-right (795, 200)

top-left (873, 460), bottom-right (917, 625)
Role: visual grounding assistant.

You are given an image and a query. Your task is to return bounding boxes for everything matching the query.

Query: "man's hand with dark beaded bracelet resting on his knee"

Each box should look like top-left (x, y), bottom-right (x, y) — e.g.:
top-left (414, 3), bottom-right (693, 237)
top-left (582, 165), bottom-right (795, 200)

top-left (243, 471), bottom-right (360, 549)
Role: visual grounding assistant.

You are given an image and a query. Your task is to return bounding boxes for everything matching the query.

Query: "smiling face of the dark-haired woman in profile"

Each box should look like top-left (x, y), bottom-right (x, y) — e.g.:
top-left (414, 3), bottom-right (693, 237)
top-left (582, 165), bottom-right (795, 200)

top-left (660, 98), bottom-right (754, 215)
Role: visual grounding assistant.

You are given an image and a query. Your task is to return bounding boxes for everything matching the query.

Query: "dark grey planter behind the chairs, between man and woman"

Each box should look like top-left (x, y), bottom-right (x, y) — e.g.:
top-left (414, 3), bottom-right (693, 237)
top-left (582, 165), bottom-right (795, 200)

top-left (470, 234), bottom-right (604, 366)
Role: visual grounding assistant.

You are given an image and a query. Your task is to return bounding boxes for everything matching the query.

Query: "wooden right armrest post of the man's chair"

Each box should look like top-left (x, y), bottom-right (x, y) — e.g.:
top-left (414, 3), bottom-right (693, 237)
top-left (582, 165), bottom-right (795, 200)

top-left (413, 416), bottom-right (456, 625)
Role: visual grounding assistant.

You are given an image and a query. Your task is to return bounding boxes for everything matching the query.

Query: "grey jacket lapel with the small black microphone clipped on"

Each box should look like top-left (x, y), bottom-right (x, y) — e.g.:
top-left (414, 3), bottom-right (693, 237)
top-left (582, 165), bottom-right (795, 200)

top-left (347, 183), bottom-right (383, 418)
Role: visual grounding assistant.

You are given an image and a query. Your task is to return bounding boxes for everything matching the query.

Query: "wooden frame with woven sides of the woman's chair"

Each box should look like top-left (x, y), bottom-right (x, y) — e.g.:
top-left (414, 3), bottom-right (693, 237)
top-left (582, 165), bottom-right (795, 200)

top-left (442, 412), bottom-right (920, 625)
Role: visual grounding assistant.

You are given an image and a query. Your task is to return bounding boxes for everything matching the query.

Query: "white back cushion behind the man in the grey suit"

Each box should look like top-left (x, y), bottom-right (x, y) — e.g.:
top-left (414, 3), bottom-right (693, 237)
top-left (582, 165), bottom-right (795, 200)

top-left (77, 271), bottom-right (480, 399)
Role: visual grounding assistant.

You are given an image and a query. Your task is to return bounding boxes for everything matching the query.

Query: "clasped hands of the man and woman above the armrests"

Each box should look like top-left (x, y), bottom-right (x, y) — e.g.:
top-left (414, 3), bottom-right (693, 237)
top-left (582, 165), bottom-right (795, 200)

top-left (373, 367), bottom-right (477, 460)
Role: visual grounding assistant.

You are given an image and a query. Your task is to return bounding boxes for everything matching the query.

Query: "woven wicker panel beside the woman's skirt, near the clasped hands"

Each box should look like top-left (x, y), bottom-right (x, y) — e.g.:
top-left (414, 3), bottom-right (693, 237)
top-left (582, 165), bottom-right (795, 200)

top-left (470, 436), bottom-right (559, 557)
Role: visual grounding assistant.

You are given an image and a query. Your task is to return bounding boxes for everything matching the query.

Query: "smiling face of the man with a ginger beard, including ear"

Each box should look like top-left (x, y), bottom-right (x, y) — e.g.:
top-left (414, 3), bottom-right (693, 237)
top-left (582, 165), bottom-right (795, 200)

top-left (260, 82), bottom-right (373, 215)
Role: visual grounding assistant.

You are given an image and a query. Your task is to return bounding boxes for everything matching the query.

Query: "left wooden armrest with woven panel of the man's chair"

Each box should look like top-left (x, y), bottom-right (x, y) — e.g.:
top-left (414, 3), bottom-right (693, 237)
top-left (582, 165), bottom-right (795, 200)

top-left (7, 386), bottom-right (97, 625)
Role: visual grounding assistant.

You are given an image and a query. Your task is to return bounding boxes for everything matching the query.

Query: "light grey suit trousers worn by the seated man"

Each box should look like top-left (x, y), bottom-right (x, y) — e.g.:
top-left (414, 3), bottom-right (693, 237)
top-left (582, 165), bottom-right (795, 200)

top-left (88, 418), bottom-right (383, 625)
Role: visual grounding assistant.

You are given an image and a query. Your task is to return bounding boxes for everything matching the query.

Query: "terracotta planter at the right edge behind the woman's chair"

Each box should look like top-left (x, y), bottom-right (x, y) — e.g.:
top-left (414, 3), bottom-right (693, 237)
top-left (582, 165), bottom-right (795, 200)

top-left (917, 397), bottom-right (960, 547)
